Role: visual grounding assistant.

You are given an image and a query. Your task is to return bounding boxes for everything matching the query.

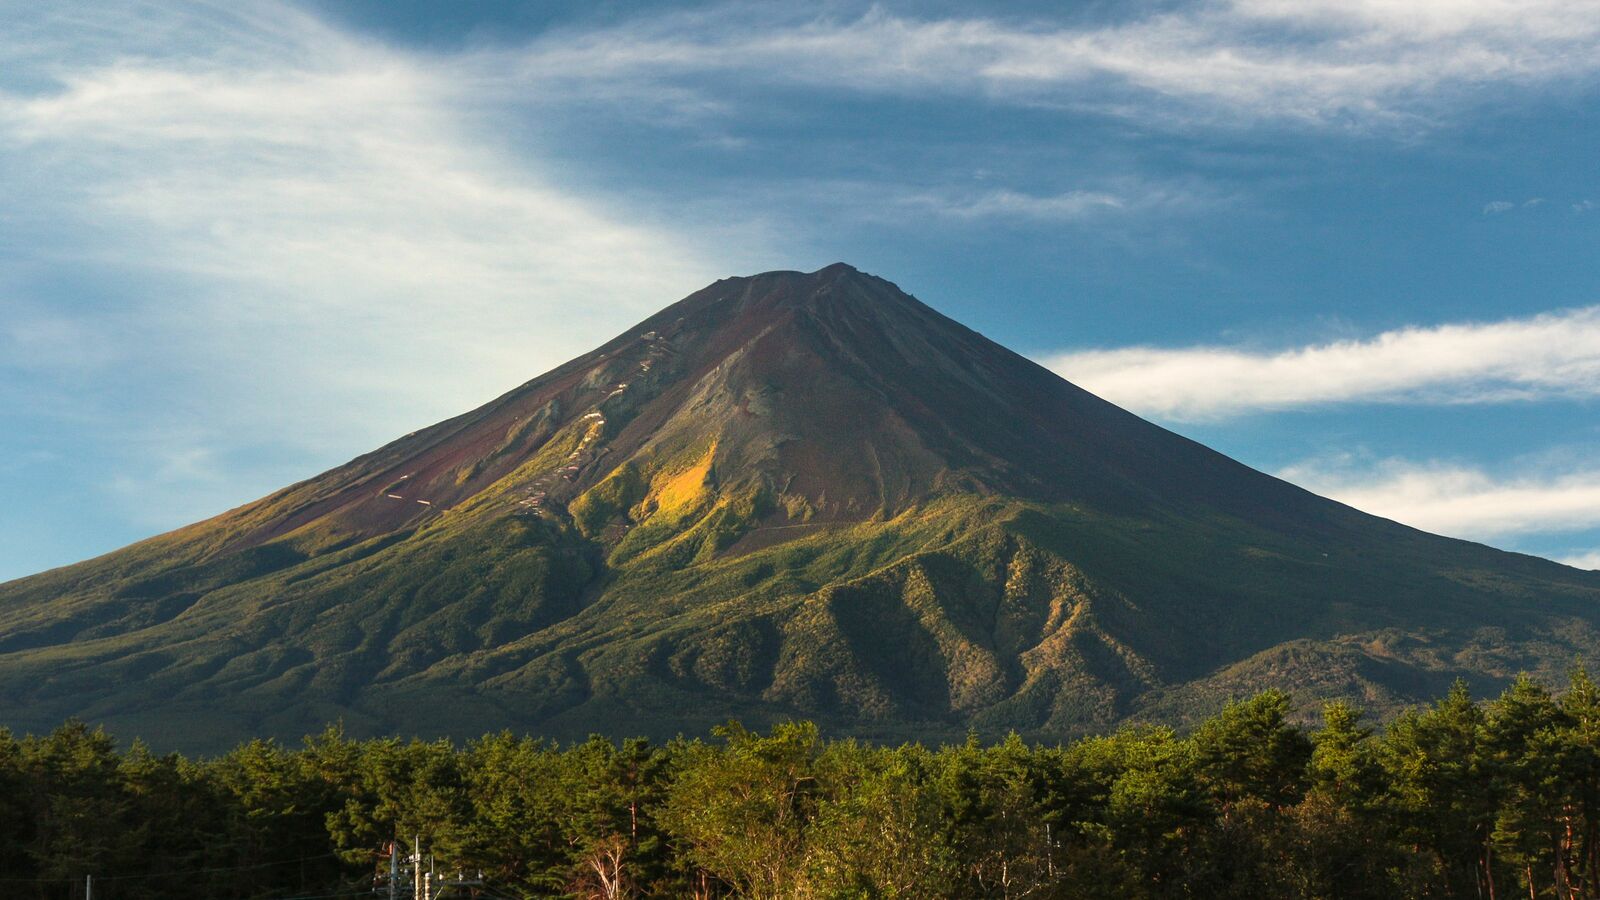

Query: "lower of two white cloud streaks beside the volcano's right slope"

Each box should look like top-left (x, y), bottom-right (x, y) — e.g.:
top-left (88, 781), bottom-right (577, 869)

top-left (1277, 456), bottom-right (1600, 540)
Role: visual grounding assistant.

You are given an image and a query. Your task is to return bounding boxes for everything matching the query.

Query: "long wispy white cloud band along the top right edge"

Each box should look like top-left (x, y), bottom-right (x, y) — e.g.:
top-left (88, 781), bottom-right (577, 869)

top-left (523, 0), bottom-right (1600, 123)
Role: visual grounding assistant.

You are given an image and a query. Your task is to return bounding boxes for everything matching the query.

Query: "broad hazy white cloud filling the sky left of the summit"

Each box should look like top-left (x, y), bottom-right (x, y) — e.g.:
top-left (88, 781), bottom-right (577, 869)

top-left (0, 3), bottom-right (744, 524)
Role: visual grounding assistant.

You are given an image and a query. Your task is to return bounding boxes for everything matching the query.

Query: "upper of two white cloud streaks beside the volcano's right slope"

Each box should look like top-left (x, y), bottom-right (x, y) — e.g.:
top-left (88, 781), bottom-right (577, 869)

top-left (1045, 306), bottom-right (1600, 421)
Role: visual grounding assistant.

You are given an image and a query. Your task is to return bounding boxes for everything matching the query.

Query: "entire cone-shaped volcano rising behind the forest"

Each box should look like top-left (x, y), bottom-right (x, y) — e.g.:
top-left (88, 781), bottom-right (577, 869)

top-left (0, 264), bottom-right (1600, 748)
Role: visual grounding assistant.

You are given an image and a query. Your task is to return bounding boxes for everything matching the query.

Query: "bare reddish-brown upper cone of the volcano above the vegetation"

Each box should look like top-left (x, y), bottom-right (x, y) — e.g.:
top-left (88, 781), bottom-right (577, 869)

top-left (225, 263), bottom-right (1318, 546)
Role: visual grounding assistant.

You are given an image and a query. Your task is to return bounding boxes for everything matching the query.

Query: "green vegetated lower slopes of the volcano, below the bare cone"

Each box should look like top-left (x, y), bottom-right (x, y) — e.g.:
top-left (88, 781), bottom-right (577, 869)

top-left (0, 477), bottom-right (1600, 748)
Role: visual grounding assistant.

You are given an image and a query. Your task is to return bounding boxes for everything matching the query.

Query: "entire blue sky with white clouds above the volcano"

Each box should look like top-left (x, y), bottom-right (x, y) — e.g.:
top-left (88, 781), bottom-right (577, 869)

top-left (0, 0), bottom-right (1600, 578)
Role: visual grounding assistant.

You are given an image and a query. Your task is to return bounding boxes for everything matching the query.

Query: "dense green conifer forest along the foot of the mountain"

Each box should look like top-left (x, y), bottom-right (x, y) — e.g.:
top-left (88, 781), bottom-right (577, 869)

top-left (9, 671), bottom-right (1600, 900)
